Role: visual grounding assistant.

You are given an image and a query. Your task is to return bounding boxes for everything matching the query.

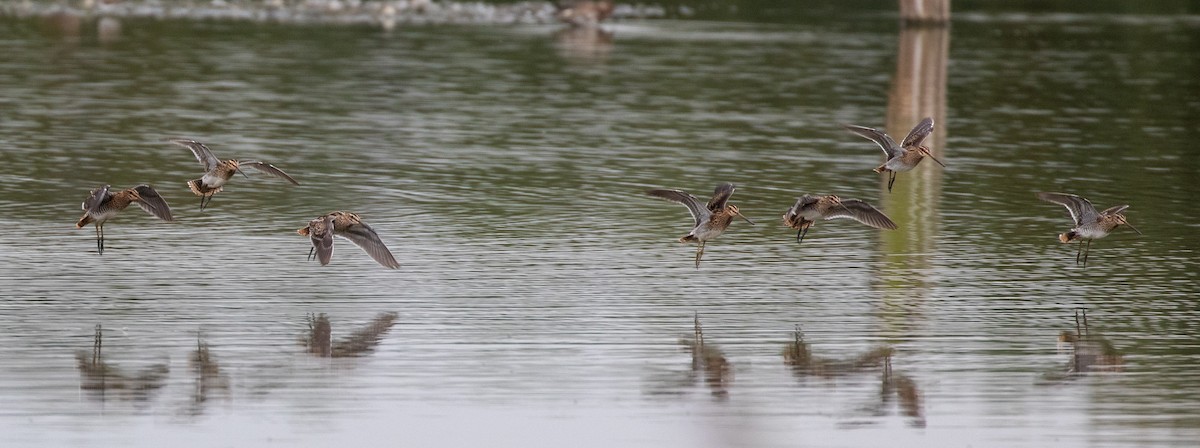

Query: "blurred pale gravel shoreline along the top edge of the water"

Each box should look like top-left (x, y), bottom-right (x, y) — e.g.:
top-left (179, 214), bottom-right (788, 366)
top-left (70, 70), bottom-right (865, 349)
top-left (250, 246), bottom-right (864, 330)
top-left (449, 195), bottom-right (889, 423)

top-left (0, 0), bottom-right (666, 29)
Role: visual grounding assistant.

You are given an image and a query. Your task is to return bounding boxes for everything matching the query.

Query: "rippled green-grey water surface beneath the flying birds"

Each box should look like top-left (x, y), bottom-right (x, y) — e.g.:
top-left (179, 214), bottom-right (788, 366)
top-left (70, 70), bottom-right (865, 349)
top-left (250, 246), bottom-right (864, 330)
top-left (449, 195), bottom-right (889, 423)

top-left (0, 6), bottom-right (1200, 447)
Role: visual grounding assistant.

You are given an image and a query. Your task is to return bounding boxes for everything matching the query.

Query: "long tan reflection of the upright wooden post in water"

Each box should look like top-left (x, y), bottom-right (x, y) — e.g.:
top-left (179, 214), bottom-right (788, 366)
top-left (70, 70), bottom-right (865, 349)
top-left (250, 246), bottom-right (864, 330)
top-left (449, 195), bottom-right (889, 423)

top-left (875, 21), bottom-right (954, 327)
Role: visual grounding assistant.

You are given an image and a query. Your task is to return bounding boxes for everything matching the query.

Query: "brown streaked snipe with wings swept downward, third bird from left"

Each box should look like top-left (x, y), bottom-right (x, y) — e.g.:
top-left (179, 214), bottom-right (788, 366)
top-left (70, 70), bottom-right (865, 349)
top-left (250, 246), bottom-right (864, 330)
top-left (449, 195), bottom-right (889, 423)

top-left (296, 211), bottom-right (400, 269)
